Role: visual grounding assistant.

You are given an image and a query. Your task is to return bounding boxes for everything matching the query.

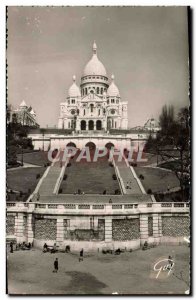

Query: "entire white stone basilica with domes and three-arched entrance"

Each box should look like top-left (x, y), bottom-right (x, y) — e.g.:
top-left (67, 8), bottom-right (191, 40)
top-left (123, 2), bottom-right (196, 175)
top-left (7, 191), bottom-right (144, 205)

top-left (58, 42), bottom-right (128, 132)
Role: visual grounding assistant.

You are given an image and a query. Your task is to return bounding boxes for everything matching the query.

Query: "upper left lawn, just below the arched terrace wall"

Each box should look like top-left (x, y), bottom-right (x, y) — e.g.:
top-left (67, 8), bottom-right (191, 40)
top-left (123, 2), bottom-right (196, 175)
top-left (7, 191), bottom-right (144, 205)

top-left (17, 151), bottom-right (49, 167)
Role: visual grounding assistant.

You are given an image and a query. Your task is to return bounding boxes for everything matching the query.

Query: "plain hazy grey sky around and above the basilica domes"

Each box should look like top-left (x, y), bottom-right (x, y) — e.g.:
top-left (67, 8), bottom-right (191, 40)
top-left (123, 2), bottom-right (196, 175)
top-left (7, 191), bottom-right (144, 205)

top-left (6, 6), bottom-right (189, 127)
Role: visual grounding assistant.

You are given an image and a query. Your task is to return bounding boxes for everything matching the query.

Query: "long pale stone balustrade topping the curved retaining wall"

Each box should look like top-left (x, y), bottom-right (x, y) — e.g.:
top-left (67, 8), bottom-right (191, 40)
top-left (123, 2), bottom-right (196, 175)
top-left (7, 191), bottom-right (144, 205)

top-left (6, 202), bottom-right (190, 215)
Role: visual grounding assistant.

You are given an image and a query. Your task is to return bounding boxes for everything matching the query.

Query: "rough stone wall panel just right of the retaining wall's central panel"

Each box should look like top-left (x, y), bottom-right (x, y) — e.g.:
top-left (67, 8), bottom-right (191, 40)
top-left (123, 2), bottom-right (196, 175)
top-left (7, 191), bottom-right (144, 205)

top-left (112, 218), bottom-right (140, 241)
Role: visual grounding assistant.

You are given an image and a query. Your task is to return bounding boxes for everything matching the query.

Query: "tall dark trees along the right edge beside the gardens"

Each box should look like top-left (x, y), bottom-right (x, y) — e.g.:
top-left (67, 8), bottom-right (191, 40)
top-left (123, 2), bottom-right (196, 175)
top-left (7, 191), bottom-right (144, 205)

top-left (147, 106), bottom-right (190, 199)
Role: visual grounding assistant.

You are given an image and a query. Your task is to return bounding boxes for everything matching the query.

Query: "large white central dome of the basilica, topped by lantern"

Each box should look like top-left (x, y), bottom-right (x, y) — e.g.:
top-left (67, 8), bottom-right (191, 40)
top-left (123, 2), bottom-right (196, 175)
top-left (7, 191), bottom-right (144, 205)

top-left (83, 42), bottom-right (107, 77)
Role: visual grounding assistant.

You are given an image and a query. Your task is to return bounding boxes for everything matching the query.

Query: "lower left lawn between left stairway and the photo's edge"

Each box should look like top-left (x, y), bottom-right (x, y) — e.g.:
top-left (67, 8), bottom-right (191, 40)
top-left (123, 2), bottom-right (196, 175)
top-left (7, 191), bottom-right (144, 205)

top-left (7, 167), bottom-right (46, 201)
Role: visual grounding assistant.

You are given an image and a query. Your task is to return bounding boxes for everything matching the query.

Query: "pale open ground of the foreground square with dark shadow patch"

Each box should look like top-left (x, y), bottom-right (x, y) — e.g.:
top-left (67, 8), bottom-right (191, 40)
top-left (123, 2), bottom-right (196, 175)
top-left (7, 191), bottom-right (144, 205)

top-left (7, 245), bottom-right (190, 295)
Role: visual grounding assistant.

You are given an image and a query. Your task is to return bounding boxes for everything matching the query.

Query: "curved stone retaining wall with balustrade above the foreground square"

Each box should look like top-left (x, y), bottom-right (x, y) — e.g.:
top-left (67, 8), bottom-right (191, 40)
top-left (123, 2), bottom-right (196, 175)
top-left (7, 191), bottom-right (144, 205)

top-left (6, 202), bottom-right (190, 250)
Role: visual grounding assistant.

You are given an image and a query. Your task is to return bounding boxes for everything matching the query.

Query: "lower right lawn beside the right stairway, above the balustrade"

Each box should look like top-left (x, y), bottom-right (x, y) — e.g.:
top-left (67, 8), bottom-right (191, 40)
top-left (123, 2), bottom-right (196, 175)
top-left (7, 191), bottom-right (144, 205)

top-left (134, 167), bottom-right (179, 193)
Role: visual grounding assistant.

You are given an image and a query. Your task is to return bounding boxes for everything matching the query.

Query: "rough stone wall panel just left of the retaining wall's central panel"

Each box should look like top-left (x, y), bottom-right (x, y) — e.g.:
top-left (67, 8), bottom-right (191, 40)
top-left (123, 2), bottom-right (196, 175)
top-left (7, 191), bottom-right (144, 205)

top-left (34, 218), bottom-right (57, 240)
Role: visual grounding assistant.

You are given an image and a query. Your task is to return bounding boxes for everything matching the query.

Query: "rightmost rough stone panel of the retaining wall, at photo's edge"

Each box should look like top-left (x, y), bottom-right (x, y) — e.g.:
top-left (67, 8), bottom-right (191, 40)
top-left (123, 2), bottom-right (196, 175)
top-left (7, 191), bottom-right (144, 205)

top-left (162, 216), bottom-right (190, 237)
